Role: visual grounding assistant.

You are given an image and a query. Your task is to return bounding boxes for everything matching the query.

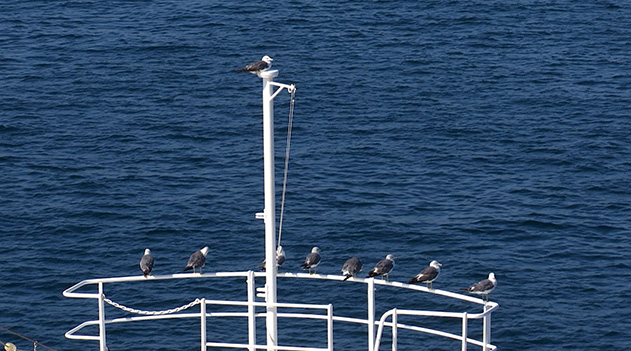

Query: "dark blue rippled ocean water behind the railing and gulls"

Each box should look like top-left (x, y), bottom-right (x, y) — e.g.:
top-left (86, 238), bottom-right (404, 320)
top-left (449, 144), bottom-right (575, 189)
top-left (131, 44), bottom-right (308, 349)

top-left (0, 0), bottom-right (631, 350)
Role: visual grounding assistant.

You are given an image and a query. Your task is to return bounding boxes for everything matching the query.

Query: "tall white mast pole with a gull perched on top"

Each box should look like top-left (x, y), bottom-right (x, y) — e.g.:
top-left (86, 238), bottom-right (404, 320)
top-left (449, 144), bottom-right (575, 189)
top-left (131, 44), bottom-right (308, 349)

top-left (259, 70), bottom-right (278, 350)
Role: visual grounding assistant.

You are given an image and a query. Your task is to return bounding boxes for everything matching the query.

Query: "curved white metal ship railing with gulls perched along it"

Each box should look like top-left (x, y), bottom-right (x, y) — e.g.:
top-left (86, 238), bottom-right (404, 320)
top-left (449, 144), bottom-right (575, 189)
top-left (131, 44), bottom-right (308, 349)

top-left (63, 271), bottom-right (499, 351)
